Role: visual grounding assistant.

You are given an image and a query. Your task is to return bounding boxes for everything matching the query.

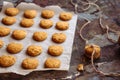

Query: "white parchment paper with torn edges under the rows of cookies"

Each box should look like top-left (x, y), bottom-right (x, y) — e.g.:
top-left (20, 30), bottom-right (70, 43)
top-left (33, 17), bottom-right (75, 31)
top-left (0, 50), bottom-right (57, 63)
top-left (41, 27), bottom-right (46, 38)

top-left (0, 2), bottom-right (77, 75)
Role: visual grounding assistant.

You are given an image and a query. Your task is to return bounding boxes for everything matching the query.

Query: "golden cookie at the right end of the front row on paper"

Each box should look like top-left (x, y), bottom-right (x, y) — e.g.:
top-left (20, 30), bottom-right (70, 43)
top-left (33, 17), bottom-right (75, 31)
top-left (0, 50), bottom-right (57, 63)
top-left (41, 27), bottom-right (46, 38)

top-left (44, 58), bottom-right (61, 68)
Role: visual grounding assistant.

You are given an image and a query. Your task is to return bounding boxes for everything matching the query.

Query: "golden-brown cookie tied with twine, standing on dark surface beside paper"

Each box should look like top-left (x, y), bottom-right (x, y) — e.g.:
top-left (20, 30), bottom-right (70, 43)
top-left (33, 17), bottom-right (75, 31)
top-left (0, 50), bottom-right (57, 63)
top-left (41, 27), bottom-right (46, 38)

top-left (85, 44), bottom-right (101, 59)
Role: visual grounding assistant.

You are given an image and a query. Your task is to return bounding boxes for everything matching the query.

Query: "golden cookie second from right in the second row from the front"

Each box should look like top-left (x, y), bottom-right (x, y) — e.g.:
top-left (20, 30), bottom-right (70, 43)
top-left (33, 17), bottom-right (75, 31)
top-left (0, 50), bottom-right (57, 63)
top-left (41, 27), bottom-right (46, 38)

top-left (27, 45), bottom-right (42, 57)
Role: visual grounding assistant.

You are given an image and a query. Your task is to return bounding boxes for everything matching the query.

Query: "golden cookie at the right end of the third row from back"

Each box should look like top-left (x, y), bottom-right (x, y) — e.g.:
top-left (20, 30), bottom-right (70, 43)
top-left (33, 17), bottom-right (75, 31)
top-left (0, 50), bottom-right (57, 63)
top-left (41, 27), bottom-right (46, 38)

top-left (52, 33), bottom-right (66, 43)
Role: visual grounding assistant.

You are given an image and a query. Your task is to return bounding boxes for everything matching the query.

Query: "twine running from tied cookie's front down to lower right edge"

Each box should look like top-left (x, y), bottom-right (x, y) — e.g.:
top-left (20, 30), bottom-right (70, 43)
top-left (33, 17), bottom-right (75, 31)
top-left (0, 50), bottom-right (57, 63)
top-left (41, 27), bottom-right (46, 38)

top-left (91, 45), bottom-right (120, 76)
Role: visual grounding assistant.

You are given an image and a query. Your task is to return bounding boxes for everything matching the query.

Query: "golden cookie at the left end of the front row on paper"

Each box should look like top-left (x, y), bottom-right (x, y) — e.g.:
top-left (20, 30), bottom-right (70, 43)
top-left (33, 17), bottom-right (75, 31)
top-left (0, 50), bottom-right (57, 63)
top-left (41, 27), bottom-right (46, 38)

top-left (0, 55), bottom-right (16, 67)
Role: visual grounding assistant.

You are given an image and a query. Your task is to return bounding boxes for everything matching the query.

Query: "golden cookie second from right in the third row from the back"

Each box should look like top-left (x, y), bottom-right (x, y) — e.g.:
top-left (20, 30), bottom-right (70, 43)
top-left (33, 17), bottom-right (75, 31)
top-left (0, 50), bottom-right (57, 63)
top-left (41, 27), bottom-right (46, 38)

top-left (33, 31), bottom-right (47, 42)
